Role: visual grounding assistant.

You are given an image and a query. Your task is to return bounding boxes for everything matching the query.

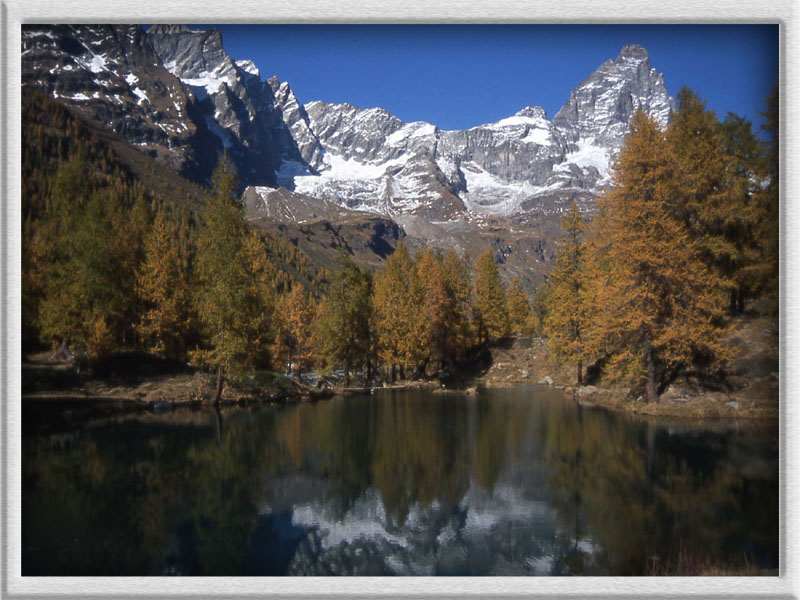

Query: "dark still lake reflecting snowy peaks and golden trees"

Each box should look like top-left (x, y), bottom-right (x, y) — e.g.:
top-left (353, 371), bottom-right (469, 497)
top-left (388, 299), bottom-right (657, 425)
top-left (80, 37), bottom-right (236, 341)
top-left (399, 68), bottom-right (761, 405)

top-left (22, 387), bottom-right (778, 575)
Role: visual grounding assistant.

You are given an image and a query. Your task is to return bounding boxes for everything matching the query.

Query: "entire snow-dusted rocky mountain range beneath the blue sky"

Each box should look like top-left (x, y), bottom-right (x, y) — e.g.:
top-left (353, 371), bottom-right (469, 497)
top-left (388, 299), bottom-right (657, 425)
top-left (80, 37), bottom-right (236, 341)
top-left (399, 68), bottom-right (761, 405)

top-left (22, 25), bottom-right (675, 288)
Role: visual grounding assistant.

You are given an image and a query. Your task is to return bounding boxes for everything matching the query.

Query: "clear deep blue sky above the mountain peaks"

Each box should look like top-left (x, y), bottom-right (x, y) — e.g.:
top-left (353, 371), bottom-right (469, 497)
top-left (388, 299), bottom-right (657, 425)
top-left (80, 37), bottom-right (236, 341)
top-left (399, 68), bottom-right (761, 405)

top-left (184, 25), bottom-right (778, 129)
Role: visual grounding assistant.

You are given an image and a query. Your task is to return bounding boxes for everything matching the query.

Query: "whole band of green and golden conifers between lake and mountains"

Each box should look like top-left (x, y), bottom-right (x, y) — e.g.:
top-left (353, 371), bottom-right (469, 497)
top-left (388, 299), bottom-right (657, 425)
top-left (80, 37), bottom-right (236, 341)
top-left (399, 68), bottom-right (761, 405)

top-left (22, 88), bottom-right (779, 401)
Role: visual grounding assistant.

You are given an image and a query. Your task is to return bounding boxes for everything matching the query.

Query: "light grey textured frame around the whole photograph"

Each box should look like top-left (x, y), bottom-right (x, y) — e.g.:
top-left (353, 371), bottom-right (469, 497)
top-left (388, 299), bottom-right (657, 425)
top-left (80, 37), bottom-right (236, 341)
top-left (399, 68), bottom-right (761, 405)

top-left (0, 0), bottom-right (800, 598)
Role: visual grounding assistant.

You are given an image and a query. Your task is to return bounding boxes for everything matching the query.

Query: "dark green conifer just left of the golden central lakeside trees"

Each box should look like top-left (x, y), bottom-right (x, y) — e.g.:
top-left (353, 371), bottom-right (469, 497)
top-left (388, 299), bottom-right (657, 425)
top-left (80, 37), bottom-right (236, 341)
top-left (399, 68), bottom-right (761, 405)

top-left (313, 249), bottom-right (372, 385)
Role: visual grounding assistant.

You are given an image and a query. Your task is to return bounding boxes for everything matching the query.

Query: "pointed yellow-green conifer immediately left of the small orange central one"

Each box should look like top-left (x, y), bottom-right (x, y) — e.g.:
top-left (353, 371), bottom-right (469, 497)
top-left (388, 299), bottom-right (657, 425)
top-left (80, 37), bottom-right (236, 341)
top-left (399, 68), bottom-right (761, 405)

top-left (473, 248), bottom-right (510, 344)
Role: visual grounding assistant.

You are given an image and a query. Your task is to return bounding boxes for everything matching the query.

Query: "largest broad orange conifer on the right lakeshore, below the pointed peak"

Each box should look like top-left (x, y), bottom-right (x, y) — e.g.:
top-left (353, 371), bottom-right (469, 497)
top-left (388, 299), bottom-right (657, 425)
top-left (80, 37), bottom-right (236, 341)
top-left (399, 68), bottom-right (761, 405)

top-left (588, 111), bottom-right (729, 402)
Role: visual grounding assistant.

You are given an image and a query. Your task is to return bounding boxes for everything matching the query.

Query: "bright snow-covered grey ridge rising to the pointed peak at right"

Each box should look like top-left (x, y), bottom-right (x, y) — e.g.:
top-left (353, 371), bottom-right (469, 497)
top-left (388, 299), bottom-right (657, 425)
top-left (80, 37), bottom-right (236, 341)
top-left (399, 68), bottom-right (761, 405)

top-left (266, 45), bottom-right (674, 220)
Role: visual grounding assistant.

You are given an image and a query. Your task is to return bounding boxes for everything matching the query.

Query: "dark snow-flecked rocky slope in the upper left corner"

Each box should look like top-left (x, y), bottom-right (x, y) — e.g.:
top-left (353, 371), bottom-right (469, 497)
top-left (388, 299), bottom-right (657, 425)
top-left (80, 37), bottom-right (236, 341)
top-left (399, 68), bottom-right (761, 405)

top-left (22, 25), bottom-right (213, 177)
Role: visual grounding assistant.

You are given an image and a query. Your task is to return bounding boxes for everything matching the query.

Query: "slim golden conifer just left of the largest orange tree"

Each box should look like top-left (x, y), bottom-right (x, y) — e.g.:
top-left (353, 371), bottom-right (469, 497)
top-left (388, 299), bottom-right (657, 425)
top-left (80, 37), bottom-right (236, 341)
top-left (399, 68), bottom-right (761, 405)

top-left (544, 201), bottom-right (594, 386)
